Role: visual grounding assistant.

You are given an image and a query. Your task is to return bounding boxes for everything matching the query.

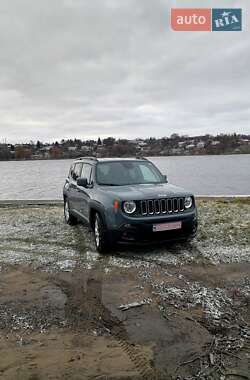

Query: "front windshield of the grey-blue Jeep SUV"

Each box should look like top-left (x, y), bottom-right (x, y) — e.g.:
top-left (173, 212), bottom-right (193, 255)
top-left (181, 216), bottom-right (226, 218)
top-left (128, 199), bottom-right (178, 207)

top-left (96, 161), bottom-right (165, 186)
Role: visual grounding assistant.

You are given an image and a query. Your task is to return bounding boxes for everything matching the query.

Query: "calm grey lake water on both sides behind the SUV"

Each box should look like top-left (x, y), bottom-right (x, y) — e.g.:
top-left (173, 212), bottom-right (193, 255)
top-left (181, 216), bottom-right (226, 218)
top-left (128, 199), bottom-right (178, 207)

top-left (0, 154), bottom-right (250, 200)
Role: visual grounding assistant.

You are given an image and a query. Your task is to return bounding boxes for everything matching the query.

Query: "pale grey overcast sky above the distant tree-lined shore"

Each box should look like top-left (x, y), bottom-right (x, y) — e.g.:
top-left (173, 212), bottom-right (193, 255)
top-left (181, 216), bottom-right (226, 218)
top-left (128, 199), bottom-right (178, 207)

top-left (0, 0), bottom-right (250, 142)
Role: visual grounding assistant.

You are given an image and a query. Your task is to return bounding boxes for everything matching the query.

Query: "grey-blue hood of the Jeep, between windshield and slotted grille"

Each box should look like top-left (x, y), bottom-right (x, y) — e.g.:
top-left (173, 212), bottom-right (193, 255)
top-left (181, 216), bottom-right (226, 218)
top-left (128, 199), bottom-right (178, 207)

top-left (100, 183), bottom-right (192, 200)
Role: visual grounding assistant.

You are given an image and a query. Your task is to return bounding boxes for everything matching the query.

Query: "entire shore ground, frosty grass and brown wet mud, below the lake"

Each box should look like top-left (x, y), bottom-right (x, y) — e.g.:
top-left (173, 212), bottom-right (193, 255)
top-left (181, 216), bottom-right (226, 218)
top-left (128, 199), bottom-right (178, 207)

top-left (0, 200), bottom-right (250, 380)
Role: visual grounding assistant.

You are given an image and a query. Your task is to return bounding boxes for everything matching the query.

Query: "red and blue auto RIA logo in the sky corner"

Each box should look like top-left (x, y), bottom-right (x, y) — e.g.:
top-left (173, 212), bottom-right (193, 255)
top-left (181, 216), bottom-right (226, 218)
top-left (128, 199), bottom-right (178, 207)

top-left (171, 8), bottom-right (242, 32)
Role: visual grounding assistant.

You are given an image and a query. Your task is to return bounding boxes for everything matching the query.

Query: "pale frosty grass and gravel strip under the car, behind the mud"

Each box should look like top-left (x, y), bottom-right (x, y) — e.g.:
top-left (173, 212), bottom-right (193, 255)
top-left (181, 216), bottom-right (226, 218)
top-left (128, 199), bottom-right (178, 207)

top-left (0, 200), bottom-right (250, 271)
